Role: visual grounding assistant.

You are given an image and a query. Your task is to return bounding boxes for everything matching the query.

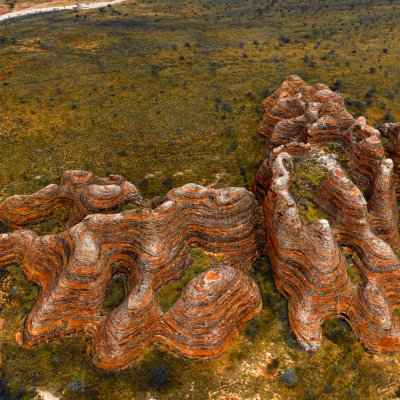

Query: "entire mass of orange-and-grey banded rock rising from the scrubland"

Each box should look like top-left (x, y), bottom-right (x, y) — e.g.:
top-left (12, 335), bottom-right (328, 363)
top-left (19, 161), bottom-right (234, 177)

top-left (0, 75), bottom-right (400, 370)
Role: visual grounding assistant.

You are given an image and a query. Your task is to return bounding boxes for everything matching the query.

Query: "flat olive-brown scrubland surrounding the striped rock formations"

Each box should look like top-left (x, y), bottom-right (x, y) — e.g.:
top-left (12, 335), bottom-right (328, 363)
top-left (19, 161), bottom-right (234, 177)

top-left (0, 0), bottom-right (400, 400)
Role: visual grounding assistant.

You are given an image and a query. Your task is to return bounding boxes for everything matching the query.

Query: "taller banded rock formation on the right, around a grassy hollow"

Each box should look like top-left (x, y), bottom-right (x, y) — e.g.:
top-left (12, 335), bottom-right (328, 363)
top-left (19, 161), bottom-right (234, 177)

top-left (253, 75), bottom-right (400, 351)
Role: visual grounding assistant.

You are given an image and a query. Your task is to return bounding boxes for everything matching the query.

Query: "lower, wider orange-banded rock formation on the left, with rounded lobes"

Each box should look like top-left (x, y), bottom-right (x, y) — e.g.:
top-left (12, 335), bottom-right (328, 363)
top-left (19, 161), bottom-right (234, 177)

top-left (0, 177), bottom-right (264, 370)
